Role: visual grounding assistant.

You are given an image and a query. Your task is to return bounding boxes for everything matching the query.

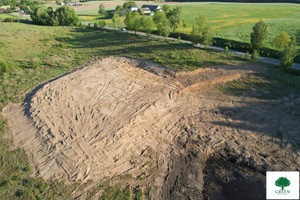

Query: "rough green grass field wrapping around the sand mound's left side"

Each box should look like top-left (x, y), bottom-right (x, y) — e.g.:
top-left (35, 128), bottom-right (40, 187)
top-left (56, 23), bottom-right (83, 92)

top-left (0, 23), bottom-right (247, 199)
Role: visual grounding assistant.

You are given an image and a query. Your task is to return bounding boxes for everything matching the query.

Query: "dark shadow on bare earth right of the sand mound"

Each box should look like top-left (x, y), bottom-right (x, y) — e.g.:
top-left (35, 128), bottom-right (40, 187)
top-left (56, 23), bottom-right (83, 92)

top-left (212, 101), bottom-right (300, 149)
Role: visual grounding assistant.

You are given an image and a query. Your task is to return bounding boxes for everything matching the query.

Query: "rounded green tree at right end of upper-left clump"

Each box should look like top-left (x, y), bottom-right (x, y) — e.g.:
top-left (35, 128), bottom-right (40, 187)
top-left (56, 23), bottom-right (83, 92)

top-left (55, 6), bottom-right (79, 26)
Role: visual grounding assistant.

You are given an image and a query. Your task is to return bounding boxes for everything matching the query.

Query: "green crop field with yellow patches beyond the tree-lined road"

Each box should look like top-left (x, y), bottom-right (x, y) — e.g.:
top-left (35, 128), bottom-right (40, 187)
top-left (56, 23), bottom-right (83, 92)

top-left (178, 3), bottom-right (300, 47)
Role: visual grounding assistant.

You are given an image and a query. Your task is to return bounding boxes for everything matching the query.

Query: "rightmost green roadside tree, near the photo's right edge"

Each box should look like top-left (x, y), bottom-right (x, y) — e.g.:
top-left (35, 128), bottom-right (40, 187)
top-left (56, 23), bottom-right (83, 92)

top-left (280, 35), bottom-right (298, 69)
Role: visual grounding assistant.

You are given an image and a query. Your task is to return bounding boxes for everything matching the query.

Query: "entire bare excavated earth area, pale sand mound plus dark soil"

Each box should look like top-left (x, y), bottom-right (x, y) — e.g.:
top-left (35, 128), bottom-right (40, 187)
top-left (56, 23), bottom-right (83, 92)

top-left (2, 57), bottom-right (300, 199)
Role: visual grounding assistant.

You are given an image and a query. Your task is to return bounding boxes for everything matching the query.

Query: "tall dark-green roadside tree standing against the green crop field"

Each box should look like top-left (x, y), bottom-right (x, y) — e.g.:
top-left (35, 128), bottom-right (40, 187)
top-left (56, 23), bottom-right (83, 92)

top-left (250, 20), bottom-right (268, 51)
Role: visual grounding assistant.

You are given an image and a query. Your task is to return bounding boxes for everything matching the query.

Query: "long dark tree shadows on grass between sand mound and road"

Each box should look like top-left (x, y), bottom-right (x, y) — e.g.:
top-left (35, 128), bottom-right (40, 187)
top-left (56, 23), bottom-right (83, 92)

top-left (56, 28), bottom-right (237, 68)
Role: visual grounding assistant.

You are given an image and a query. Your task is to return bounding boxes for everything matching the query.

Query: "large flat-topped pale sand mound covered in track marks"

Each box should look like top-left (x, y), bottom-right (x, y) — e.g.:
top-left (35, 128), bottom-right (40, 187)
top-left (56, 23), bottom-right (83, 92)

top-left (4, 58), bottom-right (202, 182)
